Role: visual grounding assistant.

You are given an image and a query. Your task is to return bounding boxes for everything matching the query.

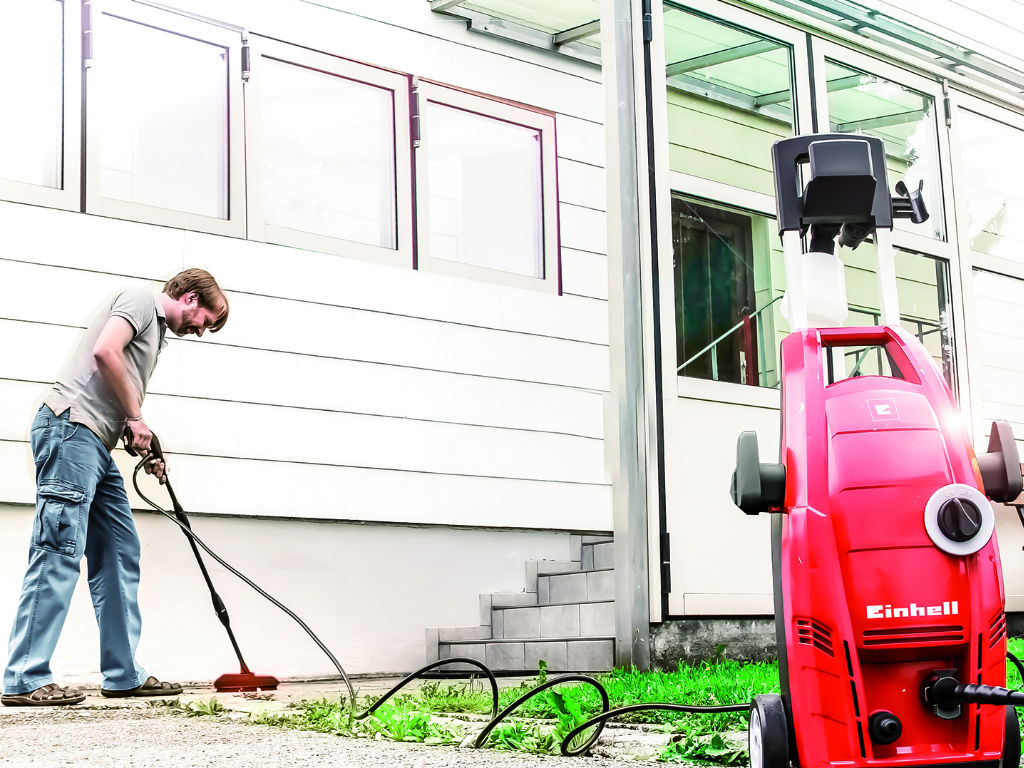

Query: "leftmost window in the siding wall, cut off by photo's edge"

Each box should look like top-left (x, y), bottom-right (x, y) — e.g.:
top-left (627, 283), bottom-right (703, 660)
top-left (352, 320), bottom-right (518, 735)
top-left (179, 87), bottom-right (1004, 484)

top-left (0, 0), bottom-right (80, 208)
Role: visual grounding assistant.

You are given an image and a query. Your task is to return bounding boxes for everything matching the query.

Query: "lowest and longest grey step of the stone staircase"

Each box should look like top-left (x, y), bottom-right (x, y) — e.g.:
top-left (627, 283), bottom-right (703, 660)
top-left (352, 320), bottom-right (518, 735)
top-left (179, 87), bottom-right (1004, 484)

top-left (437, 637), bottom-right (614, 674)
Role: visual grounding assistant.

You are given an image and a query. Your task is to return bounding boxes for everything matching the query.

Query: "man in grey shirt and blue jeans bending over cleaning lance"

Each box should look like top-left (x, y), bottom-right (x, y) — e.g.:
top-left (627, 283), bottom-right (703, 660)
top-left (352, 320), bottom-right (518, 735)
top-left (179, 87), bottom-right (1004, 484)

top-left (0, 269), bottom-right (227, 707)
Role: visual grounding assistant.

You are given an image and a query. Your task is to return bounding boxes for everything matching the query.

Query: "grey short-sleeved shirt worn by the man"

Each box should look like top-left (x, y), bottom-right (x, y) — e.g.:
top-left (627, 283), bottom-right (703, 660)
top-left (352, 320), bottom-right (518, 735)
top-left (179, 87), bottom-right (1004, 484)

top-left (43, 288), bottom-right (167, 450)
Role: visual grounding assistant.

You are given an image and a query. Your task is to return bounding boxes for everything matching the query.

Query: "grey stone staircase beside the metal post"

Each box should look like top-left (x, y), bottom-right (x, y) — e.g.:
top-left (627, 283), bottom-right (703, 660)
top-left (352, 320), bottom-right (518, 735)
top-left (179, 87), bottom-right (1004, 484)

top-left (427, 536), bottom-right (615, 674)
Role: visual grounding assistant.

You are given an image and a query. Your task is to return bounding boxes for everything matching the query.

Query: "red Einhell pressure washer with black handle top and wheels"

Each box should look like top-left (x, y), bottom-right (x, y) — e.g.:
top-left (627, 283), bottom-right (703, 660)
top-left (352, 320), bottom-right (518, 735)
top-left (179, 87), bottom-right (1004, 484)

top-left (732, 134), bottom-right (1024, 768)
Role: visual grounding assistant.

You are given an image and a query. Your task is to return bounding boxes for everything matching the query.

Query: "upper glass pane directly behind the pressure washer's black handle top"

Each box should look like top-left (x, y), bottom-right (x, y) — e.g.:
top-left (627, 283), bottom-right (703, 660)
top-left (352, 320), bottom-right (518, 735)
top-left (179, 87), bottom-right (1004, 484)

top-left (825, 58), bottom-right (945, 240)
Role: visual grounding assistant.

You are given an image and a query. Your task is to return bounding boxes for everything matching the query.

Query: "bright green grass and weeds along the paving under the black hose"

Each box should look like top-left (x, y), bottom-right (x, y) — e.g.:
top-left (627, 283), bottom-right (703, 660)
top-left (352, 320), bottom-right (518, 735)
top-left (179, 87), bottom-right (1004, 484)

top-left (214, 638), bottom-right (1024, 766)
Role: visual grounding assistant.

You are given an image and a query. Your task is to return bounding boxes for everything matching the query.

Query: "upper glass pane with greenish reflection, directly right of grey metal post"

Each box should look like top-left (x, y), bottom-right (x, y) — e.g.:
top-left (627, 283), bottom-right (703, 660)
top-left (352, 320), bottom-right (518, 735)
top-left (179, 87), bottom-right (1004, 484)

top-left (665, 4), bottom-right (795, 195)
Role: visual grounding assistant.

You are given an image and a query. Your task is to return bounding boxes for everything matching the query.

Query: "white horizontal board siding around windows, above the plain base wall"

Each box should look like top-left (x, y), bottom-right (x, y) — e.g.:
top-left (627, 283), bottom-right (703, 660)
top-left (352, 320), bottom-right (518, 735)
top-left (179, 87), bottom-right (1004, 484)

top-left (0, 0), bottom-right (611, 530)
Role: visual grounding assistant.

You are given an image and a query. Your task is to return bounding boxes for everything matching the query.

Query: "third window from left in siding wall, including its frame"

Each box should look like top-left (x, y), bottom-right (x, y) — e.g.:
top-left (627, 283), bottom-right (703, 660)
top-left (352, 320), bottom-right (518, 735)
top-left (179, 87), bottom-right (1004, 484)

top-left (246, 38), bottom-right (413, 266)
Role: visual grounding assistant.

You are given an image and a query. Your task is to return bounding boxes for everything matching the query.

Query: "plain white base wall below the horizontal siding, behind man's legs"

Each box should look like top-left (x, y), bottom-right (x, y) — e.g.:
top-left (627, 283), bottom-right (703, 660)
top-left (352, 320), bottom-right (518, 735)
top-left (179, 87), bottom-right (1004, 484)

top-left (0, 505), bottom-right (569, 686)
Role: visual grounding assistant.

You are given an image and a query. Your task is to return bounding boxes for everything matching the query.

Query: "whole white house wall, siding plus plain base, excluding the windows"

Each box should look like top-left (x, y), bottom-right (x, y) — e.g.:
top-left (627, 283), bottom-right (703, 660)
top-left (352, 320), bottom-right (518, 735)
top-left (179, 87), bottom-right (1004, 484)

top-left (0, 0), bottom-right (611, 682)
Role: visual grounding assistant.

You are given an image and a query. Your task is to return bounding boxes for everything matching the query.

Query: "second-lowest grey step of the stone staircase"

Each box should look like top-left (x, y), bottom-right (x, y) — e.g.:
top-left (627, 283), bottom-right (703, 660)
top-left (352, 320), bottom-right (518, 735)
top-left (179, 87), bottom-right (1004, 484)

top-left (489, 600), bottom-right (615, 640)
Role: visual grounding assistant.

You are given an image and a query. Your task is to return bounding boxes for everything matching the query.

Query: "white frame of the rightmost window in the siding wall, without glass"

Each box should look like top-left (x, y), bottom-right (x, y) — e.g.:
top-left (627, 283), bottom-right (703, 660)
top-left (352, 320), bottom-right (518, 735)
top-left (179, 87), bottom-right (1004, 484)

top-left (414, 80), bottom-right (561, 294)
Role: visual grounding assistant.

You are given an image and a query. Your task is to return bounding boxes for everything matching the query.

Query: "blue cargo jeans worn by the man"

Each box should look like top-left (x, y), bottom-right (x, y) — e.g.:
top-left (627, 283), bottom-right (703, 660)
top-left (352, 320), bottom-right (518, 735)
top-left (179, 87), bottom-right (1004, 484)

top-left (3, 406), bottom-right (147, 694)
